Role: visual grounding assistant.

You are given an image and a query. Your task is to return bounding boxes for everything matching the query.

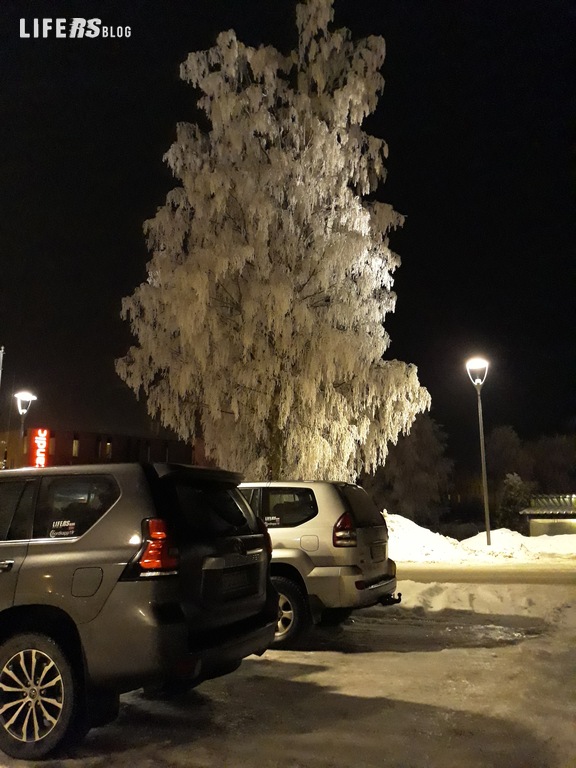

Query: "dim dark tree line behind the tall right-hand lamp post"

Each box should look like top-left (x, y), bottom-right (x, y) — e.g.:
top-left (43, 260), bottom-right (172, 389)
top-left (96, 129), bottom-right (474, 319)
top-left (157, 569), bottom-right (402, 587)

top-left (360, 414), bottom-right (576, 529)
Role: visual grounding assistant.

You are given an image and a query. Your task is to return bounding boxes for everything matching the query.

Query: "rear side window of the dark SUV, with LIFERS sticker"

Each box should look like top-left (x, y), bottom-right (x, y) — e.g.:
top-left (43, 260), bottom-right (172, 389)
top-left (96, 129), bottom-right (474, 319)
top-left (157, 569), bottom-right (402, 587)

top-left (33, 475), bottom-right (120, 539)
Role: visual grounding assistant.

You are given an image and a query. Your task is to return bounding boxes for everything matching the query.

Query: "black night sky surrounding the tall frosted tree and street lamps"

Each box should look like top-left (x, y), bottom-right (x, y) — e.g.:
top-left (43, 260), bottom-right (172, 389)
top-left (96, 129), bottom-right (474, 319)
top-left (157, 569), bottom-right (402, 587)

top-left (0, 0), bottom-right (576, 458)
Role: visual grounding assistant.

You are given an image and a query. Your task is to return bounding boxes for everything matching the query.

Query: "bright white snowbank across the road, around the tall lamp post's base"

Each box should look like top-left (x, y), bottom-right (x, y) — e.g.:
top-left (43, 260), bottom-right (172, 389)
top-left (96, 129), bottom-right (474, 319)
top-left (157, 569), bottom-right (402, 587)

top-left (385, 513), bottom-right (576, 564)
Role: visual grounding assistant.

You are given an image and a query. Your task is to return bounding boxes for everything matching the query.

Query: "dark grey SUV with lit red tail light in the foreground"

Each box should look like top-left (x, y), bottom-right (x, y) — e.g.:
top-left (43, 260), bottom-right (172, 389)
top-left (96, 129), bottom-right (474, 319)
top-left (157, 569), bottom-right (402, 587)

top-left (0, 464), bottom-right (278, 759)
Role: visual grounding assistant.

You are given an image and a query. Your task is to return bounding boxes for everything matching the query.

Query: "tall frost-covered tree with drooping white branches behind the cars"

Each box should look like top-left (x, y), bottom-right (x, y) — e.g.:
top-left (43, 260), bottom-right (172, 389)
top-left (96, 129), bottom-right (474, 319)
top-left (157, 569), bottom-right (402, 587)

top-left (116, 0), bottom-right (429, 479)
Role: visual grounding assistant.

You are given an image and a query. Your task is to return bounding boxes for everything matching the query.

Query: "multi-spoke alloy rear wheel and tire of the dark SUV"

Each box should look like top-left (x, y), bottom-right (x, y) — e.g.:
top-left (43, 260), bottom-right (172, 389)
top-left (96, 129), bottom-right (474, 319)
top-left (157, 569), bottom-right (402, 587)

top-left (0, 633), bottom-right (84, 760)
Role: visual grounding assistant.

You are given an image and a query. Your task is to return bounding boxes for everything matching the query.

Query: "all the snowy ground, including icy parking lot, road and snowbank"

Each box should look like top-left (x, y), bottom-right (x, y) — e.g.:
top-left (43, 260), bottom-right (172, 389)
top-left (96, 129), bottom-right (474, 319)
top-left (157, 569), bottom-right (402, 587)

top-left (5, 515), bottom-right (576, 768)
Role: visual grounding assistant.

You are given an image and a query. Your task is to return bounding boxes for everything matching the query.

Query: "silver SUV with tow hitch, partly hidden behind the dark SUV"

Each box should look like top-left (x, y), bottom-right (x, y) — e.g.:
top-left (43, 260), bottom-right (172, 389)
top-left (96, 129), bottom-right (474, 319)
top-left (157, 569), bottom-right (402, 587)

top-left (239, 482), bottom-right (401, 648)
